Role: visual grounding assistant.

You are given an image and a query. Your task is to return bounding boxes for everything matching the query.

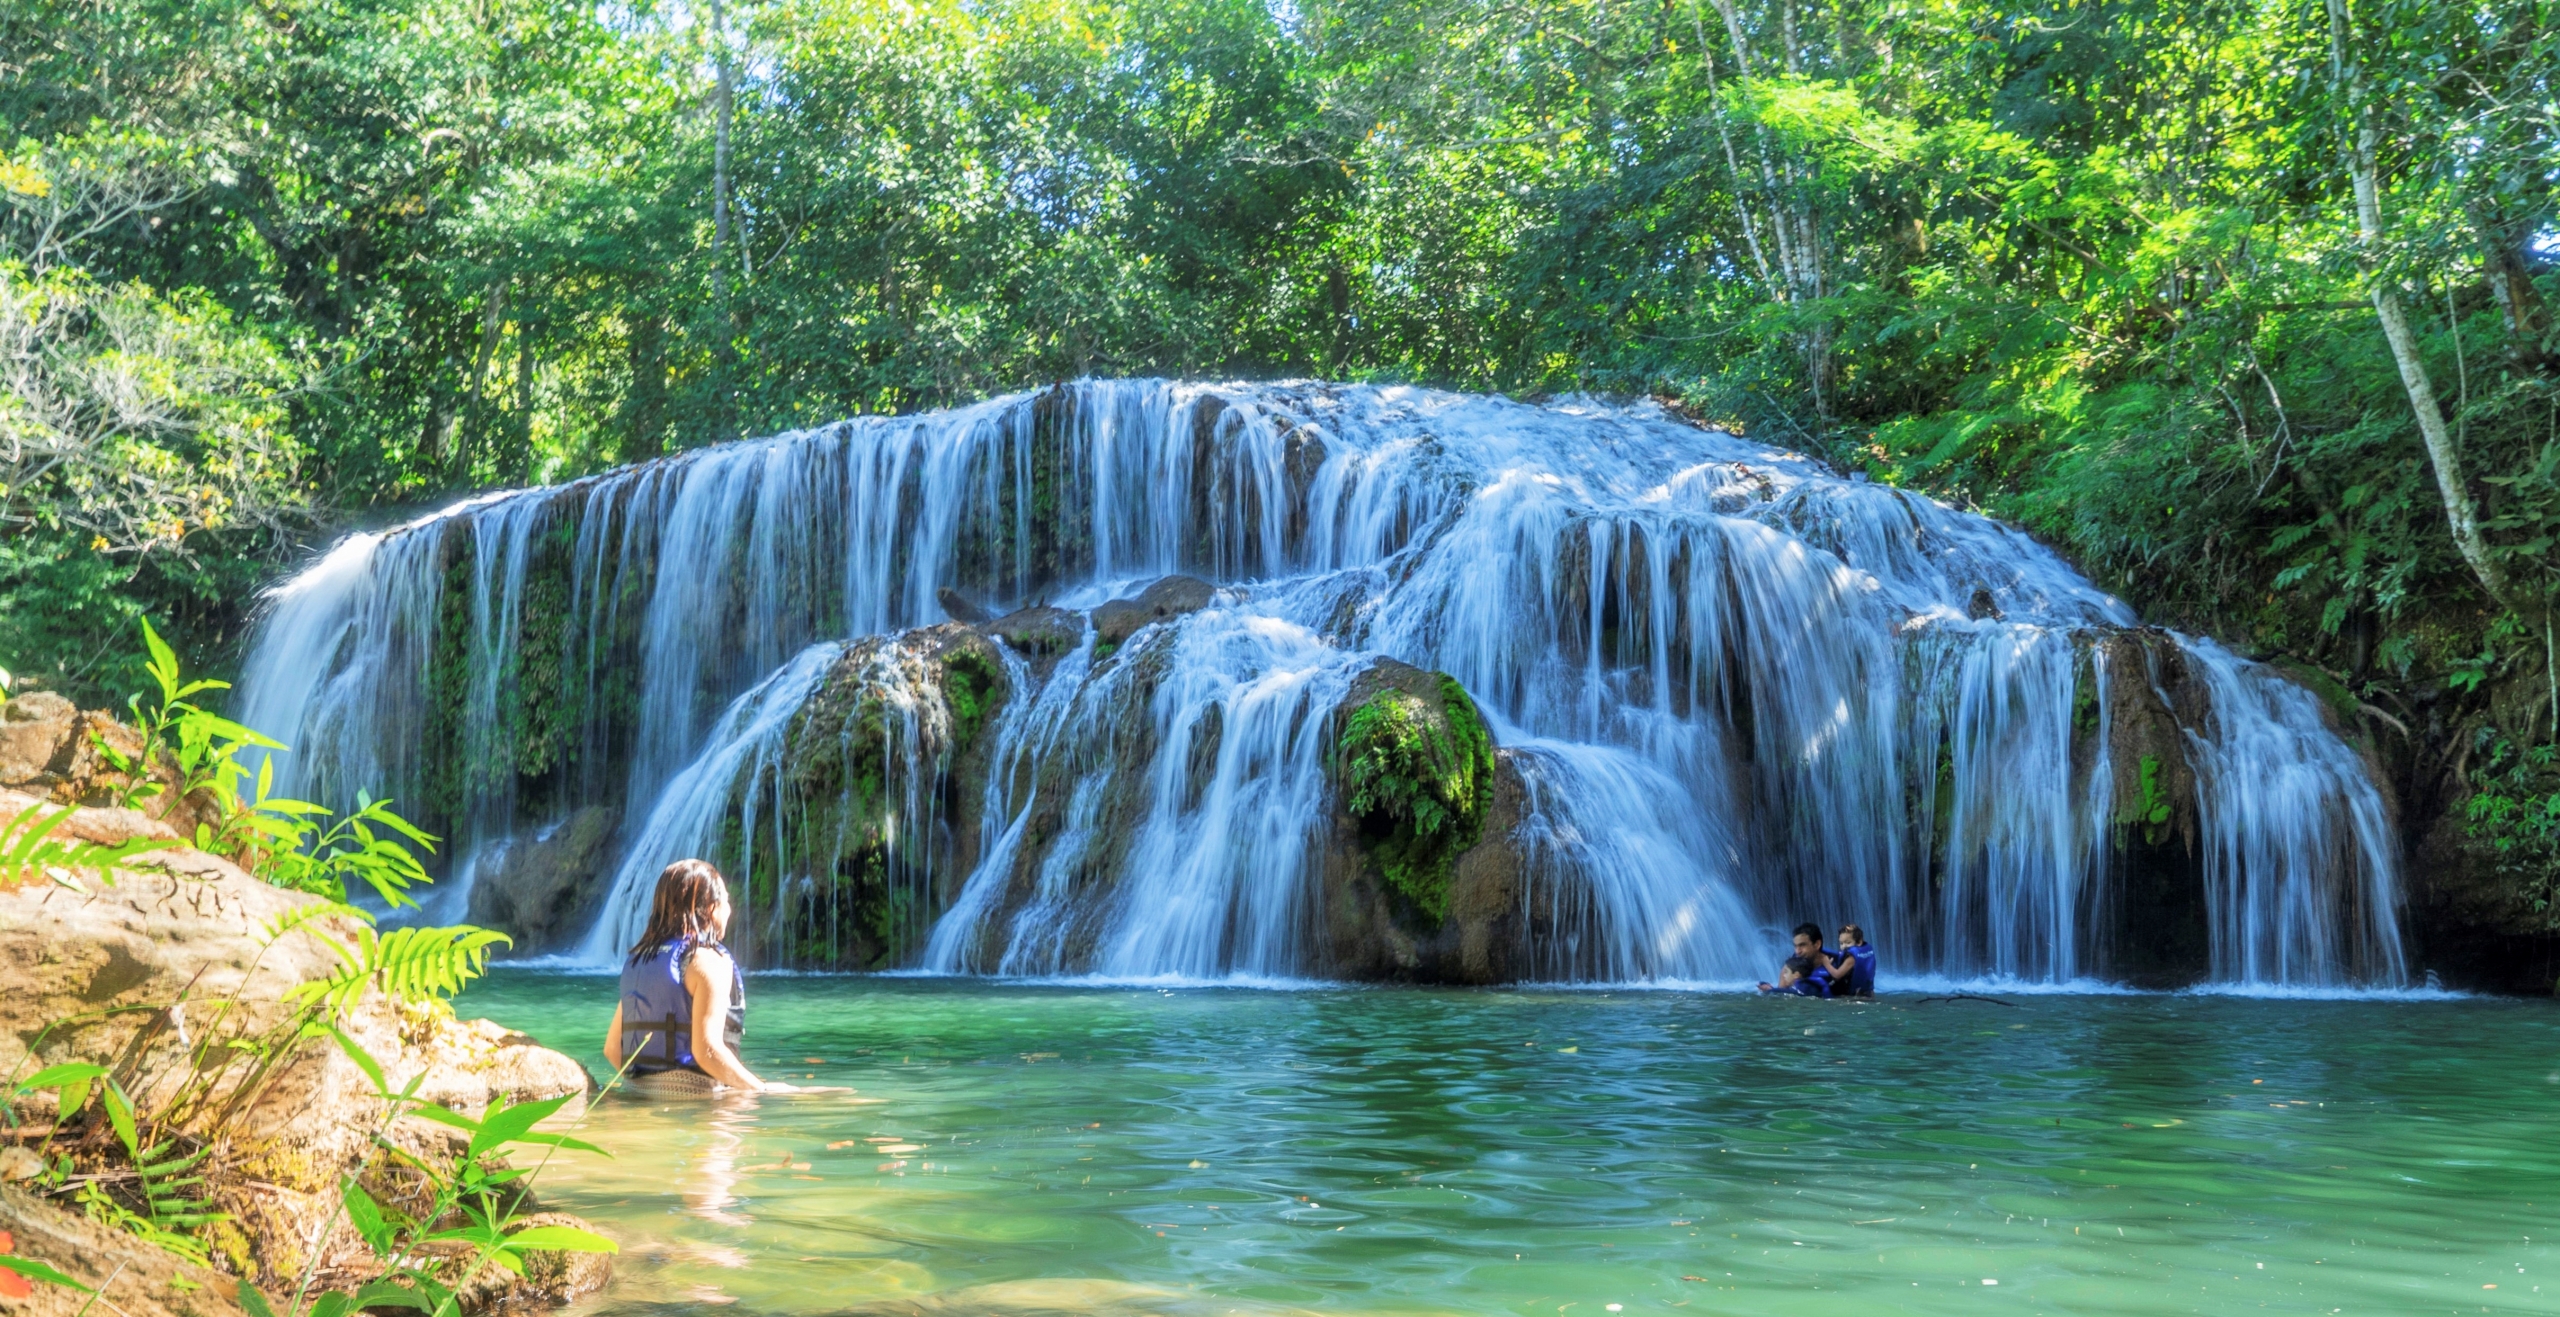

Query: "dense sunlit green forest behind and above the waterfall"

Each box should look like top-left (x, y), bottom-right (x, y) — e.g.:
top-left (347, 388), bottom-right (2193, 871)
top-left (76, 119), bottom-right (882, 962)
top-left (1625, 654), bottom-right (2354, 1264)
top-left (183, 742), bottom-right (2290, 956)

top-left (0, 0), bottom-right (2560, 928)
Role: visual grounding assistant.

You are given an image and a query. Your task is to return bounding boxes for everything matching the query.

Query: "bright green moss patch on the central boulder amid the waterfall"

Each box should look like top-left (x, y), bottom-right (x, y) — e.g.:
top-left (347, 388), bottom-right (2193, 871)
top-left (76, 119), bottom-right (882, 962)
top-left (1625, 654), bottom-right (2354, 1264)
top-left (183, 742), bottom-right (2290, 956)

top-left (1336, 676), bottom-right (1492, 925)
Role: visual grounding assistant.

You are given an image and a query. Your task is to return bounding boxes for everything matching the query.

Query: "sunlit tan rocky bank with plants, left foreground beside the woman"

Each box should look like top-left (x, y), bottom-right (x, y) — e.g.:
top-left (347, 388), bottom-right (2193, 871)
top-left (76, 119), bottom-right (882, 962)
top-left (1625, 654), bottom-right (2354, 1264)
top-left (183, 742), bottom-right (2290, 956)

top-left (0, 784), bottom-right (607, 1317)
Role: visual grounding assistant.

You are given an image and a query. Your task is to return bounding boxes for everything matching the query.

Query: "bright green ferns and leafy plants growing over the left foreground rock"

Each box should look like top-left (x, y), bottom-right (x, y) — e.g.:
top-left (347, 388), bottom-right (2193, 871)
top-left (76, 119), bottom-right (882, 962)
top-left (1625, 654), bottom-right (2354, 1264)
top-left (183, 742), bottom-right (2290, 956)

top-left (0, 623), bottom-right (555, 1296)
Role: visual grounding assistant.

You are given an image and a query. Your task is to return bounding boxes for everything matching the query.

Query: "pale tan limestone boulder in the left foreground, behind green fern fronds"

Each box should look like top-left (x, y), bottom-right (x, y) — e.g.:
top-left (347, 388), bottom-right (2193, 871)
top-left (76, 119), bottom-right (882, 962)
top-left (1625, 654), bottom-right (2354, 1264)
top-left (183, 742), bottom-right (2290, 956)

top-left (0, 792), bottom-right (591, 1291)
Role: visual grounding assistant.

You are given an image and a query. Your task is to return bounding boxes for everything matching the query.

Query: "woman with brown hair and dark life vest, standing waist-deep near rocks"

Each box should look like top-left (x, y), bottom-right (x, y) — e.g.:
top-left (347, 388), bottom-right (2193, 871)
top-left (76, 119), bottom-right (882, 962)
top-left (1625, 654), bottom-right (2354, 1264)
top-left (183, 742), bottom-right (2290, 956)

top-left (604, 861), bottom-right (791, 1092)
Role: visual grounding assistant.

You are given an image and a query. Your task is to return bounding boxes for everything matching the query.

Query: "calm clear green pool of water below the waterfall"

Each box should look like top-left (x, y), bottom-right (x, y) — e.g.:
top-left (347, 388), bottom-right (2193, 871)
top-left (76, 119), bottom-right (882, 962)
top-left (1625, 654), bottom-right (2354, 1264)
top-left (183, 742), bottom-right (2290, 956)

top-left (461, 971), bottom-right (2560, 1317)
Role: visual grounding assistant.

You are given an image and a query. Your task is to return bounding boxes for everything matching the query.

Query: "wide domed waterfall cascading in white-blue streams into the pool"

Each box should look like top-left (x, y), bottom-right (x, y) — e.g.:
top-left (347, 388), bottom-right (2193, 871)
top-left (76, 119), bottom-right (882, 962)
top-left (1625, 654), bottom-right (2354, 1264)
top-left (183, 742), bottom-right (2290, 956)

top-left (230, 382), bottom-right (2404, 984)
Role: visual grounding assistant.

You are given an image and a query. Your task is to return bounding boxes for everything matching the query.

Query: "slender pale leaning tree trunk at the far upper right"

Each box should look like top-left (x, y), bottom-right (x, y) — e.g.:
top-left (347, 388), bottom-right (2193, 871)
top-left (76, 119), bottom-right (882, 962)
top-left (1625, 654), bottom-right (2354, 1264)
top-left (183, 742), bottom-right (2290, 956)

top-left (2330, 0), bottom-right (2542, 618)
